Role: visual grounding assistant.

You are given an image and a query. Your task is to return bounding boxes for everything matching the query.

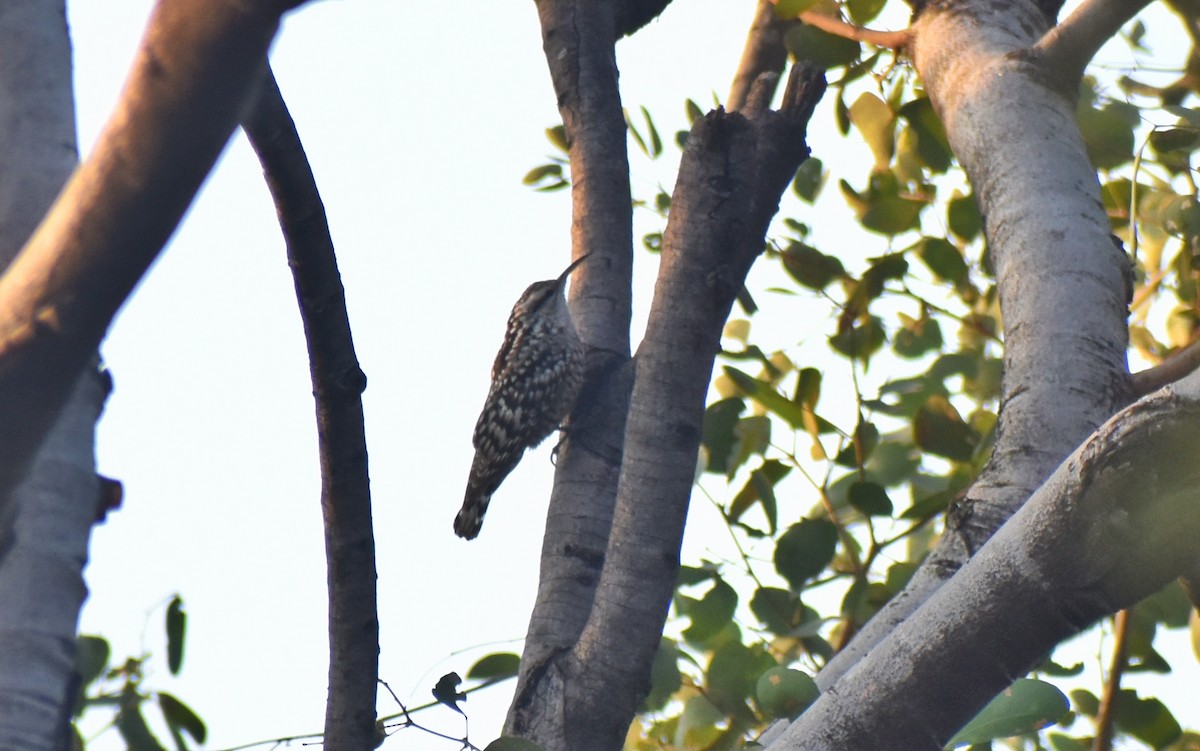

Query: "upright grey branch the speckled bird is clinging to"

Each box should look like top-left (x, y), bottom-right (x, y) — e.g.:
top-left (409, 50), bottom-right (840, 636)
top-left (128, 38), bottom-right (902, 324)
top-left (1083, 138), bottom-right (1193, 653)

top-left (505, 0), bottom-right (638, 743)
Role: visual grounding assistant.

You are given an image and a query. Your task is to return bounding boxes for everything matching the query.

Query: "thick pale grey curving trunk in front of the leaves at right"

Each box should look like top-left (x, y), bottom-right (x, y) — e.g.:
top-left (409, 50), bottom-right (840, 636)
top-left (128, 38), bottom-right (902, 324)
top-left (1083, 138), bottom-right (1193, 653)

top-left (817, 0), bottom-right (1129, 689)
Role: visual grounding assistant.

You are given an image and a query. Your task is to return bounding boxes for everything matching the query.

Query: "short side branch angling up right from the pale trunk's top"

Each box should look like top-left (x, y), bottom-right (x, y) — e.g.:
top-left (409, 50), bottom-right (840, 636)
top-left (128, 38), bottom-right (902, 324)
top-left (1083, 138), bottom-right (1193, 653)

top-left (1033, 0), bottom-right (1151, 87)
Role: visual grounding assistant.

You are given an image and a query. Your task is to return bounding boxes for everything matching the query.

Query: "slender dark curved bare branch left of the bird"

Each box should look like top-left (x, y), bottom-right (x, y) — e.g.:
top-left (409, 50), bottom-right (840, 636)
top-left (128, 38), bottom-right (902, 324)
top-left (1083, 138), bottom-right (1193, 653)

top-left (242, 67), bottom-right (379, 751)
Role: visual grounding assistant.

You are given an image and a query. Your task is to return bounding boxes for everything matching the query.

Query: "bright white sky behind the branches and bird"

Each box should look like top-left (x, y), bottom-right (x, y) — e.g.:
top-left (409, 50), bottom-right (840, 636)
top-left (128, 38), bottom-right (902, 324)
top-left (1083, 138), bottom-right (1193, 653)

top-left (70, 0), bottom-right (1196, 751)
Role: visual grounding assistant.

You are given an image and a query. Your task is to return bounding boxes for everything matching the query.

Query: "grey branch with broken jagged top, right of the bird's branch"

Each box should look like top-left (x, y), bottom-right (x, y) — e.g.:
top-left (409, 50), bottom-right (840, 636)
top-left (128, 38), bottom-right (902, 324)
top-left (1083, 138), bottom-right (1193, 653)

top-left (506, 27), bottom-right (824, 751)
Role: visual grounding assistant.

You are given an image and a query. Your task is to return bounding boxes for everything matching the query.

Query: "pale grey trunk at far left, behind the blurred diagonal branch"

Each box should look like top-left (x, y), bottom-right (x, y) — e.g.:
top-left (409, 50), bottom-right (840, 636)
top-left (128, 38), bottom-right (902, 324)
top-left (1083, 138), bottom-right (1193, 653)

top-left (0, 0), bottom-right (99, 751)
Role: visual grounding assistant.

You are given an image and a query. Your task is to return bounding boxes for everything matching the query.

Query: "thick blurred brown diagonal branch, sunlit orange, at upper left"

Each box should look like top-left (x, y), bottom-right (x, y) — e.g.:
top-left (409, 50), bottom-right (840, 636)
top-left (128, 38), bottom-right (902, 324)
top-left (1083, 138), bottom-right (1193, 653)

top-left (0, 0), bottom-right (309, 516)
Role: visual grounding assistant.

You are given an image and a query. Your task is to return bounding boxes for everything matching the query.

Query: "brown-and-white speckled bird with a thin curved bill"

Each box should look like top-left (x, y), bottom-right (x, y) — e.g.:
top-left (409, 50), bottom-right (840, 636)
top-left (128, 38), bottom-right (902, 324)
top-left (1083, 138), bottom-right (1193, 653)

top-left (454, 254), bottom-right (588, 540)
